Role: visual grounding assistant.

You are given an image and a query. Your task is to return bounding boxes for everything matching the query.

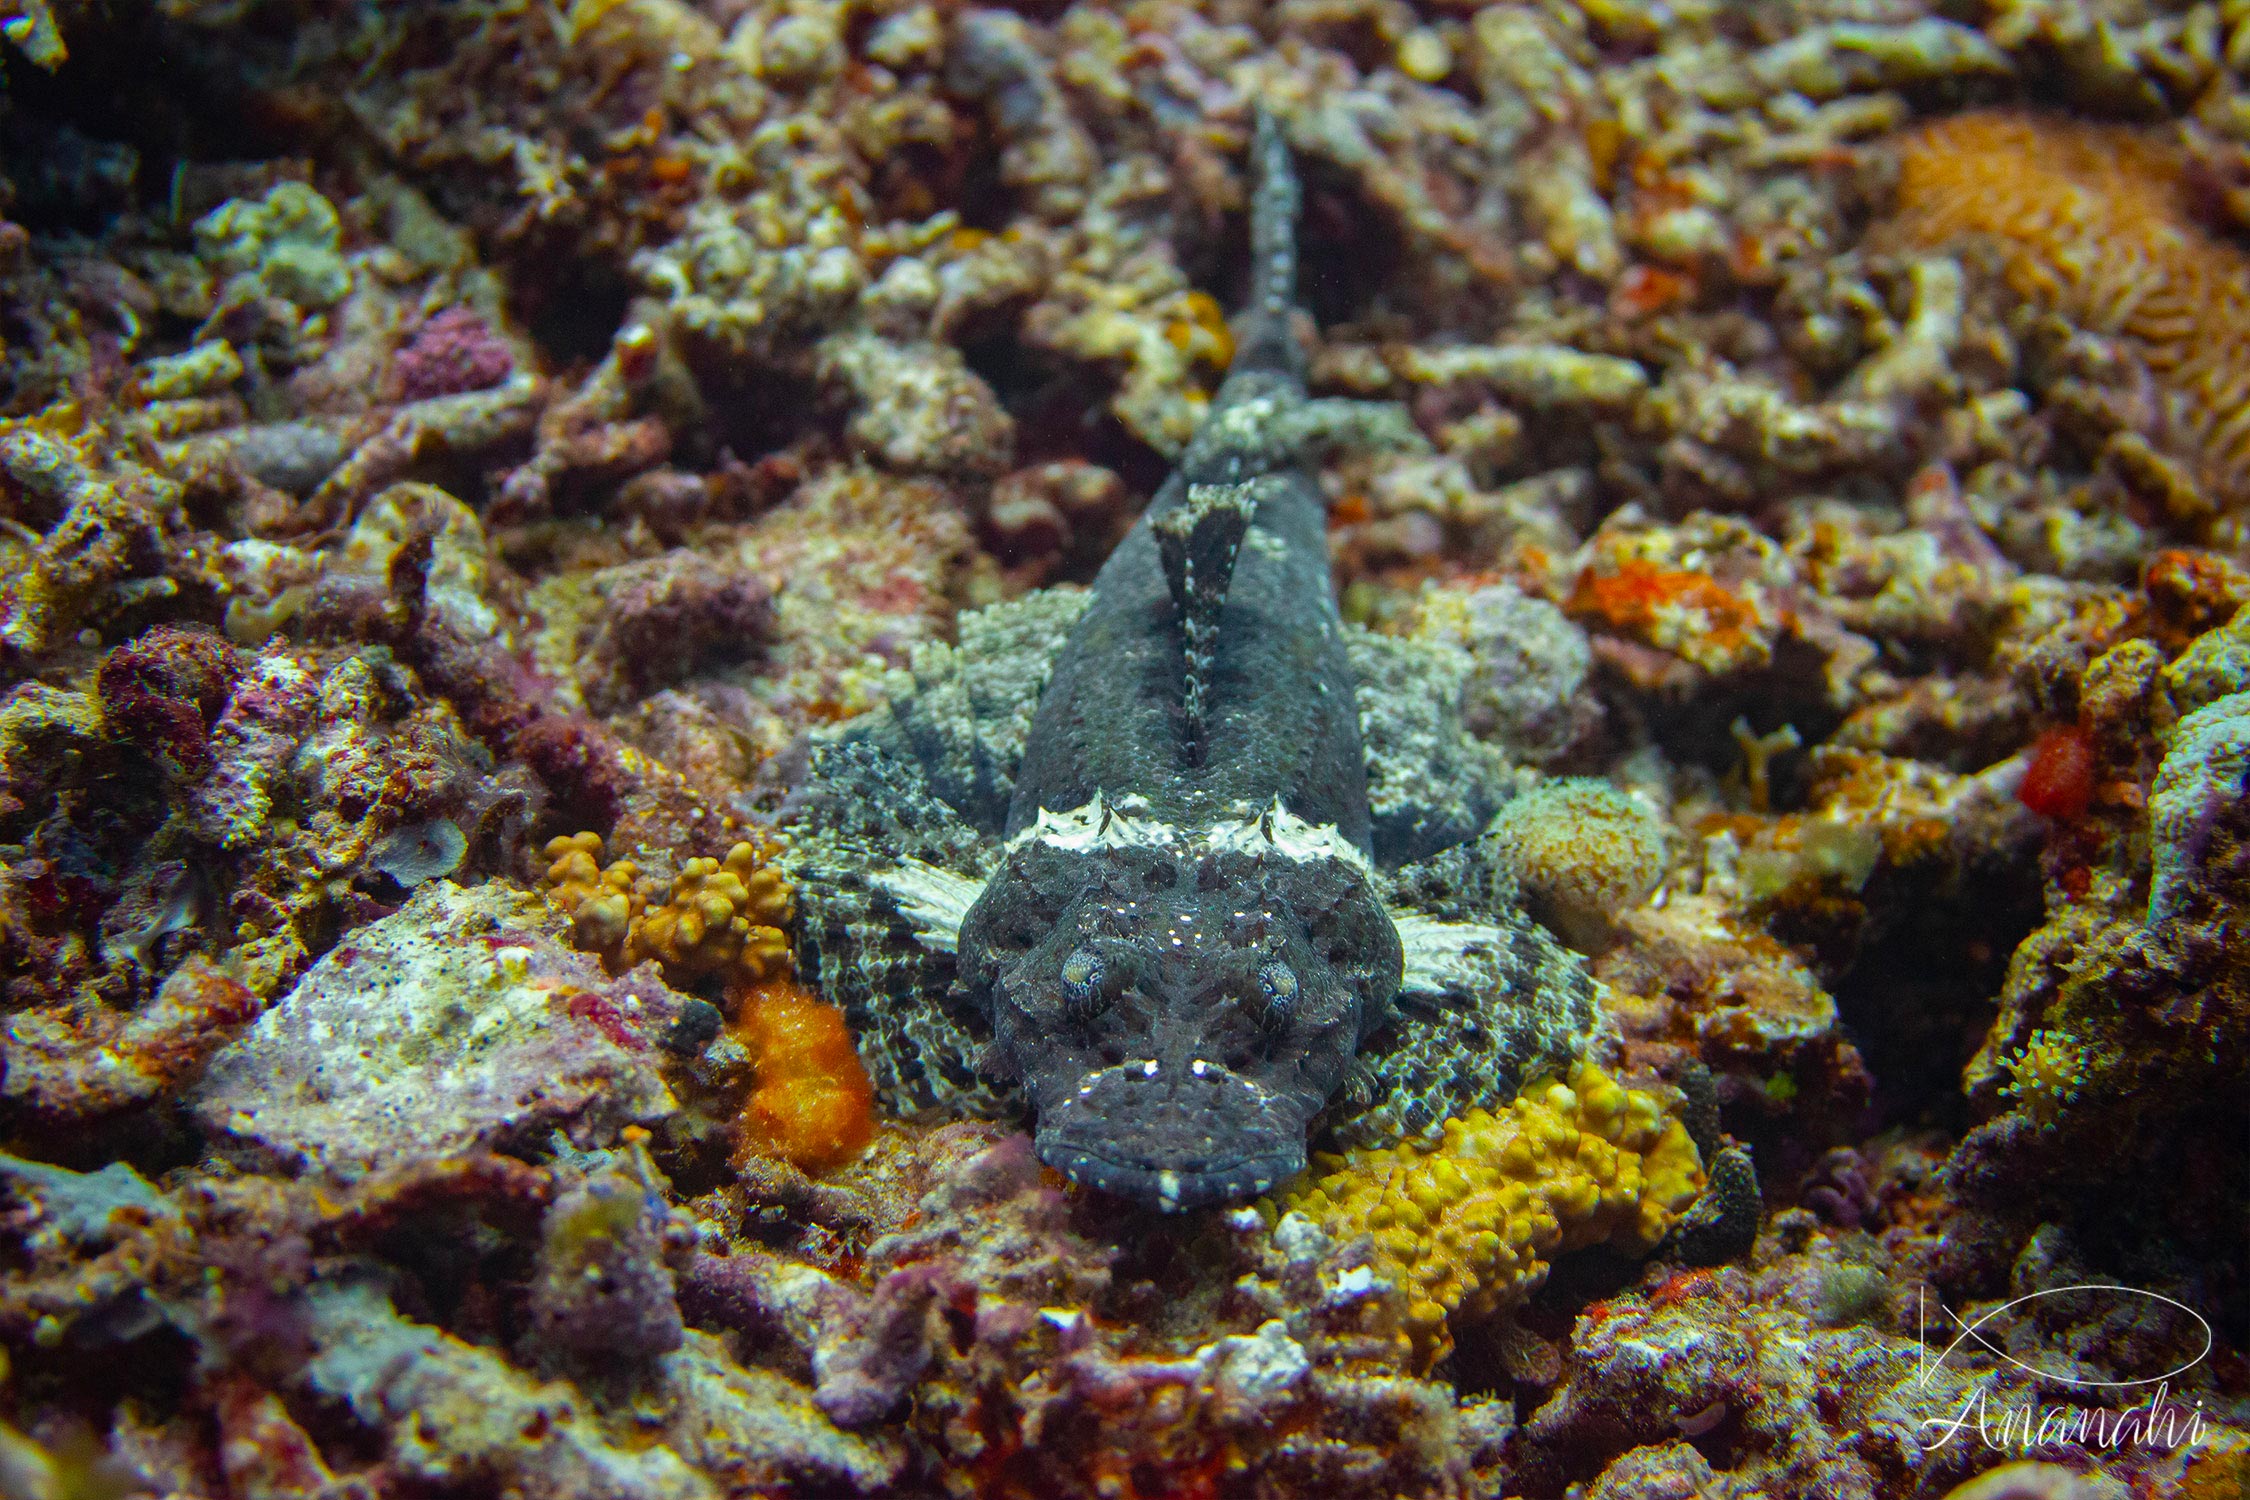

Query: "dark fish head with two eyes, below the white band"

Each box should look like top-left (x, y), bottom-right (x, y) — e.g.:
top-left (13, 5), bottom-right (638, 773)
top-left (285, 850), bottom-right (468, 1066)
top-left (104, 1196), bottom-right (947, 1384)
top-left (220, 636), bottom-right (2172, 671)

top-left (961, 843), bottom-right (1402, 1210)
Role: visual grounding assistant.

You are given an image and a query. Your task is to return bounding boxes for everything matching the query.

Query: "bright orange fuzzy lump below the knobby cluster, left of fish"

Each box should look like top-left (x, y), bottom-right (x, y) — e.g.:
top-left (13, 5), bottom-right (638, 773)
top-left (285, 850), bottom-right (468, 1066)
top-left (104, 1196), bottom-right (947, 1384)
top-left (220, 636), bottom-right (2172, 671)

top-left (734, 978), bottom-right (875, 1172)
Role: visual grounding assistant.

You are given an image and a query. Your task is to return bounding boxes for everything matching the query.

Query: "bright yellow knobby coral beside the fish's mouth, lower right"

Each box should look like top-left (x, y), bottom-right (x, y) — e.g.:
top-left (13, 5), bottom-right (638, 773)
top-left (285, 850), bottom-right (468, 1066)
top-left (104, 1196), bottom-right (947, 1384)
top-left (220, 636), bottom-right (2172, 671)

top-left (1269, 1064), bottom-right (1703, 1363)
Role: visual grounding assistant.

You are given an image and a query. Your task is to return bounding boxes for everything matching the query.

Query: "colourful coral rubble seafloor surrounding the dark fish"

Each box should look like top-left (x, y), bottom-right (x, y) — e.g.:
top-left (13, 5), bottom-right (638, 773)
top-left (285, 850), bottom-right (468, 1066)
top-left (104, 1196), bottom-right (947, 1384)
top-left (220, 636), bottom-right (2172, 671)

top-left (0, 0), bottom-right (2250, 1500)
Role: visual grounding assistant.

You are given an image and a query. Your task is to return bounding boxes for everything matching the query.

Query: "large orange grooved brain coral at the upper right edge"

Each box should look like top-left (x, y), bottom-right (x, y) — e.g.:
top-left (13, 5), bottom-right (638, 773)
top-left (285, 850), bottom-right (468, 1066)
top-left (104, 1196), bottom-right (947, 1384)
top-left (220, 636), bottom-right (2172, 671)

top-left (1895, 112), bottom-right (2250, 504)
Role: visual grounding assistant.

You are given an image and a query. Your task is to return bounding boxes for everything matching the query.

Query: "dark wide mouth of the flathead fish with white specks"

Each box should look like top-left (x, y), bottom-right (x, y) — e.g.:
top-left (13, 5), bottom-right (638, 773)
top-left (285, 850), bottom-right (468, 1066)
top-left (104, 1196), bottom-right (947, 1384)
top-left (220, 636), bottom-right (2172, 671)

top-left (1037, 1061), bottom-right (1305, 1214)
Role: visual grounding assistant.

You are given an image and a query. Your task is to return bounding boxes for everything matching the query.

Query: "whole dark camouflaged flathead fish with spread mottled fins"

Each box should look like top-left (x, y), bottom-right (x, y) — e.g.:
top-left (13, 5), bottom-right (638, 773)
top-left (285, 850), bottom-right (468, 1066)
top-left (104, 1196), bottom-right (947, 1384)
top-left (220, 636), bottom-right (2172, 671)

top-left (792, 119), bottom-right (1595, 1210)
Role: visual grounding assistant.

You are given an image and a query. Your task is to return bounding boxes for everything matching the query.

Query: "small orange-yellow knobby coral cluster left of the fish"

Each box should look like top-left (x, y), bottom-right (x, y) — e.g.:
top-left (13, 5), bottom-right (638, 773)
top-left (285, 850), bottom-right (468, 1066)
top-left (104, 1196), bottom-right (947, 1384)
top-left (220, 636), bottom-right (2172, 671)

top-left (540, 832), bottom-right (794, 983)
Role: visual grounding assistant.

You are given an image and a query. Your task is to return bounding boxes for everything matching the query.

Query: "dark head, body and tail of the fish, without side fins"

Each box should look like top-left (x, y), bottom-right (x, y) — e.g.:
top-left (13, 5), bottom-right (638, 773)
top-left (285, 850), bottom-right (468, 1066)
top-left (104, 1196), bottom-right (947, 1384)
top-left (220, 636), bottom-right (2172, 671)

top-left (961, 121), bottom-right (1402, 1208)
